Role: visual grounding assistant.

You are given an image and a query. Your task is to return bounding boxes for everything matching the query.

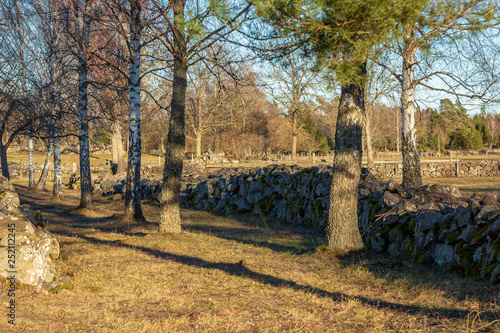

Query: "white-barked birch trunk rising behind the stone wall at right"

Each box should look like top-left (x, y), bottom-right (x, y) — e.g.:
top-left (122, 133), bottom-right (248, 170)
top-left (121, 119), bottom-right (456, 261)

top-left (401, 28), bottom-right (422, 186)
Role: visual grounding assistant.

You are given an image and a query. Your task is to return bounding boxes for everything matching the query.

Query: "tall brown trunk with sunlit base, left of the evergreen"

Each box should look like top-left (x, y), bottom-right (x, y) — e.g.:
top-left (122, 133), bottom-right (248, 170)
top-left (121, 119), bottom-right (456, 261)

top-left (160, 0), bottom-right (187, 233)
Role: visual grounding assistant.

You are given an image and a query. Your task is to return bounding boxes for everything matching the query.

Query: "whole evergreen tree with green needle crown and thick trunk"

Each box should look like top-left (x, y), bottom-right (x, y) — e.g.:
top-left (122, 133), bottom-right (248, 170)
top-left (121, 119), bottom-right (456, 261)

top-left (257, 0), bottom-right (423, 251)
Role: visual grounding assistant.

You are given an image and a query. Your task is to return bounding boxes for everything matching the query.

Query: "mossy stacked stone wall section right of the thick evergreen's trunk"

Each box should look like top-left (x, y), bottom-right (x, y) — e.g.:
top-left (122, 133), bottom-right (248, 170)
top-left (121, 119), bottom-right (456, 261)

top-left (358, 181), bottom-right (500, 282)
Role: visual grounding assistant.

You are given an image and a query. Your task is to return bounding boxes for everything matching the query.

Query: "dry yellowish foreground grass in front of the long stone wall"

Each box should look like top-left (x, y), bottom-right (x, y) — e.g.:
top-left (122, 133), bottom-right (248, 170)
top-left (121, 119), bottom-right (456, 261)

top-left (0, 182), bottom-right (500, 332)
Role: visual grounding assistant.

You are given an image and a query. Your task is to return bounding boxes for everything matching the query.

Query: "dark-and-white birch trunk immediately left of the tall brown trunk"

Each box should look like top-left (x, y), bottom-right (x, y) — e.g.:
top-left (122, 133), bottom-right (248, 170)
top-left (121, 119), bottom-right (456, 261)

top-left (125, 0), bottom-right (144, 222)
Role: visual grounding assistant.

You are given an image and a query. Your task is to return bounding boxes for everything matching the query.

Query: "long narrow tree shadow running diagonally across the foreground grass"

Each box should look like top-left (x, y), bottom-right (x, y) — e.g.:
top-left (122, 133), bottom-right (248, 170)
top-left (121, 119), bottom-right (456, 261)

top-left (49, 231), bottom-right (498, 320)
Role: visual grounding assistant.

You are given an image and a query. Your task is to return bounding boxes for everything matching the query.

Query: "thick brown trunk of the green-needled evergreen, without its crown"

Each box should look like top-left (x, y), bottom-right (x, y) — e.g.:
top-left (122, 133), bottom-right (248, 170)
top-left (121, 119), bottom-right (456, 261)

top-left (327, 66), bottom-right (366, 251)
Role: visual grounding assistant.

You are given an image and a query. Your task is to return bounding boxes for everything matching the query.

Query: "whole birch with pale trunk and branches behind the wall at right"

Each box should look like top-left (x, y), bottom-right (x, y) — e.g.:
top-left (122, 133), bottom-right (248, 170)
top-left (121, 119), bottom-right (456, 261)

top-left (381, 0), bottom-right (500, 186)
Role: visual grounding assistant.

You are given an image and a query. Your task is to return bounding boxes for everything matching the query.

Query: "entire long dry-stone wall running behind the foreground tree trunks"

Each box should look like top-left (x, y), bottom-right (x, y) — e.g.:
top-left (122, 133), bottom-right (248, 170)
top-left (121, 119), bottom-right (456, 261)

top-left (94, 165), bottom-right (500, 282)
